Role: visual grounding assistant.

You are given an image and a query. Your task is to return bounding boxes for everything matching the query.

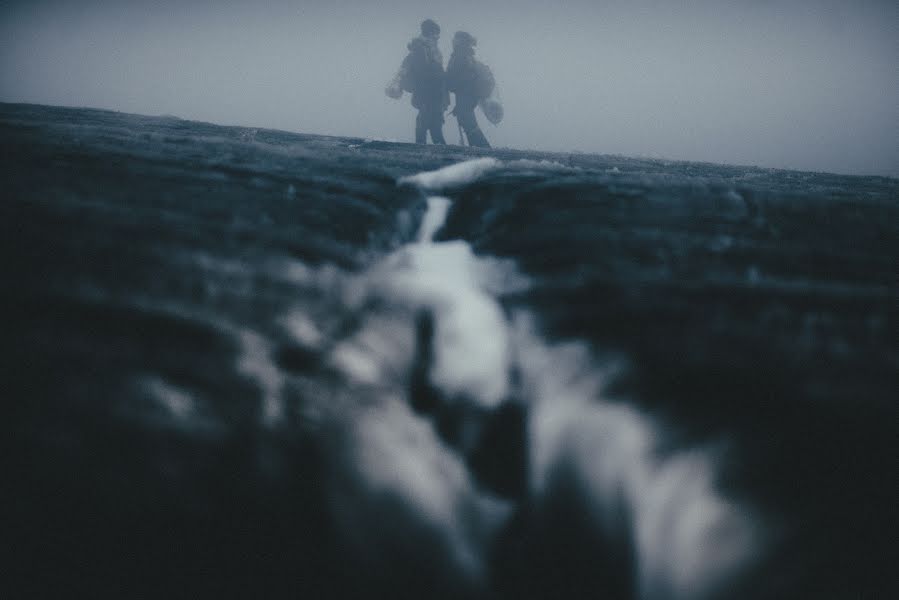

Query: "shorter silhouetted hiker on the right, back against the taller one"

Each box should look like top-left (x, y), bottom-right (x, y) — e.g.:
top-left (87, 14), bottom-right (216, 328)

top-left (446, 31), bottom-right (496, 148)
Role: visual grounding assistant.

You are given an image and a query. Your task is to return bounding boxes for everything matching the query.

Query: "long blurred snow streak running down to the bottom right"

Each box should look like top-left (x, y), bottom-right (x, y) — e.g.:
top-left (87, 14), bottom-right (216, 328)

top-left (515, 319), bottom-right (763, 598)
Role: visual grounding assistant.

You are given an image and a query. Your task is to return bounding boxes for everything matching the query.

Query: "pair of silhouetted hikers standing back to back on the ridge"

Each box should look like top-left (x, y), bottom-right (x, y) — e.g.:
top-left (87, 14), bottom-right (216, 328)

top-left (386, 19), bottom-right (502, 148)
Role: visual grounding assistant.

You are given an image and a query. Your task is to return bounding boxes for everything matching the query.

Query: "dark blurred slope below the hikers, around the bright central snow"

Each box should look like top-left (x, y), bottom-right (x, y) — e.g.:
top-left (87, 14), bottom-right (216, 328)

top-left (0, 104), bottom-right (899, 598)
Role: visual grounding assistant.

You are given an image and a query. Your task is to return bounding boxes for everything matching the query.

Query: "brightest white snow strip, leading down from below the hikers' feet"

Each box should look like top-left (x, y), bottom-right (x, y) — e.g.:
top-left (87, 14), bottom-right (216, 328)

top-left (370, 175), bottom-right (523, 408)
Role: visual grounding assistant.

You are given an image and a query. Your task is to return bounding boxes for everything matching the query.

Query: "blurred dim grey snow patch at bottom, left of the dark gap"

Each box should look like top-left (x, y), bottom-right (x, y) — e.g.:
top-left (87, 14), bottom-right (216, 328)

top-left (330, 396), bottom-right (509, 596)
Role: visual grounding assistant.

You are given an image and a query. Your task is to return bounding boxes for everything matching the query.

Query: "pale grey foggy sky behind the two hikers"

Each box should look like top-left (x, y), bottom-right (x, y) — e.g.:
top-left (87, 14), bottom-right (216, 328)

top-left (0, 0), bottom-right (899, 176)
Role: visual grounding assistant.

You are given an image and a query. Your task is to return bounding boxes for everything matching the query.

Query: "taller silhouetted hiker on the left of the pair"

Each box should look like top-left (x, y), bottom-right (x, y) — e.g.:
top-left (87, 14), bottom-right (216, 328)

top-left (400, 19), bottom-right (449, 144)
